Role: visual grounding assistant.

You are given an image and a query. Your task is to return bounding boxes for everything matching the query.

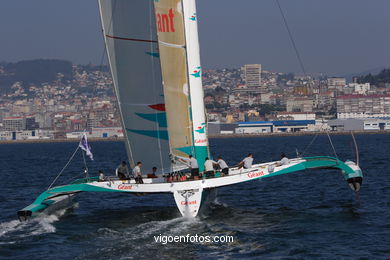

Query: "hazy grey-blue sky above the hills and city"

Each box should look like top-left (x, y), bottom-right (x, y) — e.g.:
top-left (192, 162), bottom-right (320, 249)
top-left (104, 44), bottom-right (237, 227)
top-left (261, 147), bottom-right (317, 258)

top-left (0, 0), bottom-right (390, 75)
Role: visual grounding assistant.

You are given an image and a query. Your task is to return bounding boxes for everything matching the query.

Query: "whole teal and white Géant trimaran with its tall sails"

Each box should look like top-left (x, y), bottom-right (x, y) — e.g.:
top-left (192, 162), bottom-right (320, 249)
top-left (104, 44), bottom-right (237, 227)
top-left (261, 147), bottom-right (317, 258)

top-left (18, 0), bottom-right (363, 220)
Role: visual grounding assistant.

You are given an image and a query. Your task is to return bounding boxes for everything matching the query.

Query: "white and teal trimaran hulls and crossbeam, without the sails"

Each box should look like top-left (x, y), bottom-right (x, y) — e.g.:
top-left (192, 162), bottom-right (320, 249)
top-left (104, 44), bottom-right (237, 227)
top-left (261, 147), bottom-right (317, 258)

top-left (18, 156), bottom-right (363, 220)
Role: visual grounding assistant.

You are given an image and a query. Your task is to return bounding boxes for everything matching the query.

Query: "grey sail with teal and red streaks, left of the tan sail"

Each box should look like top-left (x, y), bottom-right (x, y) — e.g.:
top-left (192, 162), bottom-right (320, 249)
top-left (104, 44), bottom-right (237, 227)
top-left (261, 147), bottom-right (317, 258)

top-left (99, 0), bottom-right (171, 175)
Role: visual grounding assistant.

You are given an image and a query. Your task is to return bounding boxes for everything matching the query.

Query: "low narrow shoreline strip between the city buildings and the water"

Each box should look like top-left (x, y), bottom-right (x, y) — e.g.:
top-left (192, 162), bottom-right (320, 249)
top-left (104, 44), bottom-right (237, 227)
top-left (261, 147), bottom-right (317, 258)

top-left (0, 130), bottom-right (390, 144)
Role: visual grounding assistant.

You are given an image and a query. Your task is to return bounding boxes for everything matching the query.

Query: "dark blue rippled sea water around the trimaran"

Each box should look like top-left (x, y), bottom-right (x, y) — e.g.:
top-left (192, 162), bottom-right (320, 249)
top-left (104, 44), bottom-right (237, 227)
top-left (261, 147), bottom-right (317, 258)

top-left (0, 135), bottom-right (390, 260)
